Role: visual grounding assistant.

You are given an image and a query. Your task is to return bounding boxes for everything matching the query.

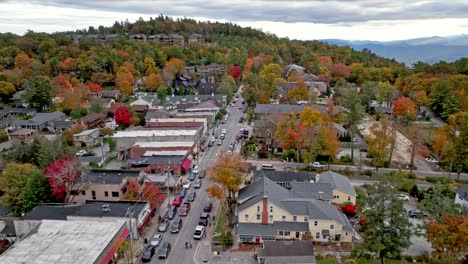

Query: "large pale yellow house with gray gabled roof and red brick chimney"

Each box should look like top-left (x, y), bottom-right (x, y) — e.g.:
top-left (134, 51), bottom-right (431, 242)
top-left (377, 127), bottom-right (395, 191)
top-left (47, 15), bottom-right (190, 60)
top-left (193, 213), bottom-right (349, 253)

top-left (236, 177), bottom-right (354, 243)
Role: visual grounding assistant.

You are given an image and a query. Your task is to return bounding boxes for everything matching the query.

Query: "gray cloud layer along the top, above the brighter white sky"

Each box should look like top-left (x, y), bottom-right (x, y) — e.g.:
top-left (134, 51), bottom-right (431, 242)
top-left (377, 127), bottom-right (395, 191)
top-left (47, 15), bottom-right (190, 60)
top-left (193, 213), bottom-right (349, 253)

top-left (11, 0), bottom-right (468, 24)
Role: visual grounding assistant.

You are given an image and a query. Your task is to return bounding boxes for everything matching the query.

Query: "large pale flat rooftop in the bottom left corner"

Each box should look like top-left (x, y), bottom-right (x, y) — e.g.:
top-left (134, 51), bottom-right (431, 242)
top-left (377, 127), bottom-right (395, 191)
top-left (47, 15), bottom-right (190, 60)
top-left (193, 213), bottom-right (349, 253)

top-left (0, 220), bottom-right (125, 264)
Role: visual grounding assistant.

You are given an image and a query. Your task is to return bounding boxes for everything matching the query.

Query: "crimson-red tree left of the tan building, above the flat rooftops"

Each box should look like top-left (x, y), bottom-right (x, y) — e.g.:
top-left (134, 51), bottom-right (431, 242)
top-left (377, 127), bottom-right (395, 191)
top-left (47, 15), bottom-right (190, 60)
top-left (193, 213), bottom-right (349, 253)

top-left (44, 156), bottom-right (82, 204)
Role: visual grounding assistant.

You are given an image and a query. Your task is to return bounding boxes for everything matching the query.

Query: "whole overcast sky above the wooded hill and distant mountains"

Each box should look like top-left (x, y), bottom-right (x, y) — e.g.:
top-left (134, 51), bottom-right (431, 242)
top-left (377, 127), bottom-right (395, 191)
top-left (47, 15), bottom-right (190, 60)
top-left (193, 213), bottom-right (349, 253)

top-left (0, 0), bottom-right (468, 41)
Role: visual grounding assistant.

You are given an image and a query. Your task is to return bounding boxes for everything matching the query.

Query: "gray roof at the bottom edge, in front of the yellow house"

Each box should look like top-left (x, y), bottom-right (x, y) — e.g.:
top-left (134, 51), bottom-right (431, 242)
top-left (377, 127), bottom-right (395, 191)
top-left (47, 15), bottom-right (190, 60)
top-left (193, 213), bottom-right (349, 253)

top-left (258, 240), bottom-right (314, 257)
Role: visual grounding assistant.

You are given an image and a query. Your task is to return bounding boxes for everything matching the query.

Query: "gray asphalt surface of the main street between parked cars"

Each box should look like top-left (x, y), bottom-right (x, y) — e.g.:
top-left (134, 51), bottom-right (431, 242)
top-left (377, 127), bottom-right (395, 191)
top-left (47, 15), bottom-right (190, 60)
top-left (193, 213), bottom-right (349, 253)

top-left (149, 96), bottom-right (243, 264)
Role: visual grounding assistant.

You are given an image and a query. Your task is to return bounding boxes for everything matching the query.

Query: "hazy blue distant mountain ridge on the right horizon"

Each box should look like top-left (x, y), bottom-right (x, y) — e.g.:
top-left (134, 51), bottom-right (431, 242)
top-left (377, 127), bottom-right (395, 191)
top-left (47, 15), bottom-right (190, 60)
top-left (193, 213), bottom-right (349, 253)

top-left (321, 34), bottom-right (468, 66)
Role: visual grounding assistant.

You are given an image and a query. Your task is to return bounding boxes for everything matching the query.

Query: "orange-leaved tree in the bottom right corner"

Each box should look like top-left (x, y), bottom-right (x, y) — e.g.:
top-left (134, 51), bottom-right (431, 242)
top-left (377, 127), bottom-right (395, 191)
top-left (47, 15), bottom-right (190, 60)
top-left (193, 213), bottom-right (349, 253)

top-left (427, 216), bottom-right (468, 263)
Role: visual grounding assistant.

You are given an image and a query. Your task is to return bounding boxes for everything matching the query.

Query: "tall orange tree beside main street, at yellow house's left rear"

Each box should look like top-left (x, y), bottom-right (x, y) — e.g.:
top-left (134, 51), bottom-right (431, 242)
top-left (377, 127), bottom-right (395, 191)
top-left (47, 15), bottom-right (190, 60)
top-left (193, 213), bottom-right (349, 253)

top-left (206, 153), bottom-right (248, 207)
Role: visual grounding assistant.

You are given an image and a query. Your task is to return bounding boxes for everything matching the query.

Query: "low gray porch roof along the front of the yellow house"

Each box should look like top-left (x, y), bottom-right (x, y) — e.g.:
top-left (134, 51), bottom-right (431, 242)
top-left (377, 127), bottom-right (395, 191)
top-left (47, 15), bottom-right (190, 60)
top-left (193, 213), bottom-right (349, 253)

top-left (236, 222), bottom-right (309, 236)
